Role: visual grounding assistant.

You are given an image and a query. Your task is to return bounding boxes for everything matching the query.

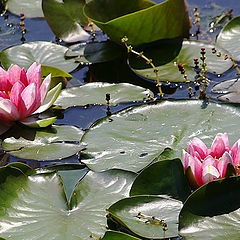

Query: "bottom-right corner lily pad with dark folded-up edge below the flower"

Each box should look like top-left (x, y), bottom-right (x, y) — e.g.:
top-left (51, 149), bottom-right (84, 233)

top-left (179, 176), bottom-right (240, 240)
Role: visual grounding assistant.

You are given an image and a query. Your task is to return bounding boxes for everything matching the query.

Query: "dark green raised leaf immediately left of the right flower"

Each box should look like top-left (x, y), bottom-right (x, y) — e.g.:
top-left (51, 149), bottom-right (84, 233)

top-left (130, 159), bottom-right (191, 202)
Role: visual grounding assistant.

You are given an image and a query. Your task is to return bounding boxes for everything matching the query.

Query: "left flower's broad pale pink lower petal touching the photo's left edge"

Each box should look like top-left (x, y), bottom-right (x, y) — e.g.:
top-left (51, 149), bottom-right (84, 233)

top-left (0, 97), bottom-right (19, 122)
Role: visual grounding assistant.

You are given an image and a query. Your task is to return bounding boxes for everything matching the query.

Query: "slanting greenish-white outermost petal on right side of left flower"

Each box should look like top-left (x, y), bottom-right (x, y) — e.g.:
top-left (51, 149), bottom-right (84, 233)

top-left (33, 83), bottom-right (62, 114)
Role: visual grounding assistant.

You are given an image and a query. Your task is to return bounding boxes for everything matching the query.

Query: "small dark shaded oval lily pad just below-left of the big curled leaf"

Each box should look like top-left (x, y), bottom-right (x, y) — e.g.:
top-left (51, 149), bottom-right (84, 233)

top-left (65, 41), bottom-right (124, 64)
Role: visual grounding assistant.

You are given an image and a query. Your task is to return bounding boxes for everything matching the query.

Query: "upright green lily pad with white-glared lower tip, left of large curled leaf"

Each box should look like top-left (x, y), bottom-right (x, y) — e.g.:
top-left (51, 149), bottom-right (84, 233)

top-left (42, 0), bottom-right (90, 42)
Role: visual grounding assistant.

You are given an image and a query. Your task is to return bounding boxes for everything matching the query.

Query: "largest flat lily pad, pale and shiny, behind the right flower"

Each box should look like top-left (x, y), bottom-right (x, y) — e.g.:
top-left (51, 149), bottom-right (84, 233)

top-left (82, 100), bottom-right (240, 172)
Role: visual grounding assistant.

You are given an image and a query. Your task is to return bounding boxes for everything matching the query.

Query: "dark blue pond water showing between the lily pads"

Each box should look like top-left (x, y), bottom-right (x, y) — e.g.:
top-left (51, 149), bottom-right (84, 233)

top-left (0, 0), bottom-right (240, 167)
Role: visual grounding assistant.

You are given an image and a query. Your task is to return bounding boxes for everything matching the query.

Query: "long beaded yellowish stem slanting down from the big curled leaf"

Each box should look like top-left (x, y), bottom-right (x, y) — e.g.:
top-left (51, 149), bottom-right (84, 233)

top-left (122, 37), bottom-right (164, 97)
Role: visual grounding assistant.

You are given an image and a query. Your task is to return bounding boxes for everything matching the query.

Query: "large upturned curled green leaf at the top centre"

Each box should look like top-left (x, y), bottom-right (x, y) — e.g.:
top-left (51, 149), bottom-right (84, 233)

top-left (84, 0), bottom-right (190, 46)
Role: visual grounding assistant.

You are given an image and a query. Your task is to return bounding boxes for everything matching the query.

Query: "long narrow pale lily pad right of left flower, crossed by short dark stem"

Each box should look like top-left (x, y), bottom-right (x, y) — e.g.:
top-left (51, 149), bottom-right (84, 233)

top-left (55, 82), bottom-right (153, 108)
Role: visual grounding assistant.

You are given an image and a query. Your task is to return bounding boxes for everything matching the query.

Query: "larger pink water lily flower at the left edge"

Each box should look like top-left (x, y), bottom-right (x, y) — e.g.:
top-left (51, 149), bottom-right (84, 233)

top-left (0, 63), bottom-right (61, 134)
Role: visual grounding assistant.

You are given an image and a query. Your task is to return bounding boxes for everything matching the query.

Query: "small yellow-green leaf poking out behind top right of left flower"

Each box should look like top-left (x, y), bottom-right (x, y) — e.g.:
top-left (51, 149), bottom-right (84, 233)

top-left (41, 65), bottom-right (72, 88)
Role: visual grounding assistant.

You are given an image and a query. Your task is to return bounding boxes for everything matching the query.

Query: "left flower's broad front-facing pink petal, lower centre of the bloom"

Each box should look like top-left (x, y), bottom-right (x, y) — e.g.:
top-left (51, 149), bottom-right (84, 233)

top-left (21, 83), bottom-right (36, 118)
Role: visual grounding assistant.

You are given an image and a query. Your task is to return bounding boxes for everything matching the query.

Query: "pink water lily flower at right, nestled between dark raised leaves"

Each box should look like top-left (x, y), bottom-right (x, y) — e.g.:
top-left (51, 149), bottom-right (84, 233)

top-left (182, 133), bottom-right (240, 189)
